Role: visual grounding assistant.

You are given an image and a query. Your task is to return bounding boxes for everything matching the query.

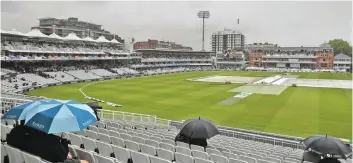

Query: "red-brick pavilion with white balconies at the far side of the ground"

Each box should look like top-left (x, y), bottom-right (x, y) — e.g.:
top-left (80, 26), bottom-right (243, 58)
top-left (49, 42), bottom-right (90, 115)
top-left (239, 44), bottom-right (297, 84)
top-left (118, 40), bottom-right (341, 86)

top-left (249, 46), bottom-right (334, 69)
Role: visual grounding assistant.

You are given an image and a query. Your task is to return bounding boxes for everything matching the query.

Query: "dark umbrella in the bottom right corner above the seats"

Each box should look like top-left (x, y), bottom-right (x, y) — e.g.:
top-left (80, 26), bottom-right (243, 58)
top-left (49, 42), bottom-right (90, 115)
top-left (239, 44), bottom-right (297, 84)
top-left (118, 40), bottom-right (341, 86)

top-left (303, 135), bottom-right (352, 159)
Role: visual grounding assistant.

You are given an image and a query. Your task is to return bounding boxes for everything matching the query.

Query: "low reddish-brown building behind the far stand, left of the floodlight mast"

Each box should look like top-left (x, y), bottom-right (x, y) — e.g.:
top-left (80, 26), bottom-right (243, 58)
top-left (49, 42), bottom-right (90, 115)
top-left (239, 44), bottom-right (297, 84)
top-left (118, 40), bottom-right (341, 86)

top-left (134, 39), bottom-right (192, 51)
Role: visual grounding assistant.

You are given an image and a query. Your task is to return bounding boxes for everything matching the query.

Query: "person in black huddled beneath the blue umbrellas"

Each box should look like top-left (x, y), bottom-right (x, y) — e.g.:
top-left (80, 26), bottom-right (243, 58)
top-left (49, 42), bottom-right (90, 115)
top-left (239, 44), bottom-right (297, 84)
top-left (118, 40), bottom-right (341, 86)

top-left (6, 121), bottom-right (88, 163)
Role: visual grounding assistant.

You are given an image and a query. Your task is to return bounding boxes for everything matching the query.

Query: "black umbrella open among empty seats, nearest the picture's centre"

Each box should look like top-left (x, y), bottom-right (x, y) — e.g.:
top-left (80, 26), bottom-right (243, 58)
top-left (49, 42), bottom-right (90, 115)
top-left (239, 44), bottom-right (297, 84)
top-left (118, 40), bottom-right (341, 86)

top-left (179, 118), bottom-right (219, 139)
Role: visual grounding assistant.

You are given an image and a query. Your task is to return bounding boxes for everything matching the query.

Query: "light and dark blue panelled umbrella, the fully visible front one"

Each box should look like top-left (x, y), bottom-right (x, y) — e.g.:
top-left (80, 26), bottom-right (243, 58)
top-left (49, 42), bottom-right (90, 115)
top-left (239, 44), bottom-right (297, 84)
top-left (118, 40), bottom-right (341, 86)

top-left (25, 100), bottom-right (97, 134)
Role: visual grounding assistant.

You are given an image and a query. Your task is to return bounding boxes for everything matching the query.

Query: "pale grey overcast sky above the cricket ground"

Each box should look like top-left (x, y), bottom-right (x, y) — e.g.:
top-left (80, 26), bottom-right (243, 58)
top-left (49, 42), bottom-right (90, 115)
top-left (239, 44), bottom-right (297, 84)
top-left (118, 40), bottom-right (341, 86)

top-left (1, 1), bottom-right (352, 50)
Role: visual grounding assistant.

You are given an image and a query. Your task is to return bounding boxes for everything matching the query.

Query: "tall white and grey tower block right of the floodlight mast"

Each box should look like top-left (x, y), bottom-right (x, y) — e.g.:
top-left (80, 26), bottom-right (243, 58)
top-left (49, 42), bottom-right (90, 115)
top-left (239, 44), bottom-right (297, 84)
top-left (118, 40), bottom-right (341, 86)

top-left (211, 29), bottom-right (245, 52)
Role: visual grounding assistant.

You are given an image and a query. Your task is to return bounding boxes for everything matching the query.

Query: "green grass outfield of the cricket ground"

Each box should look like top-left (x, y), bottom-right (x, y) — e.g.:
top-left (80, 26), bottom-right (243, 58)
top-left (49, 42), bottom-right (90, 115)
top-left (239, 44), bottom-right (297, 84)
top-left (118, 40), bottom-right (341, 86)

top-left (28, 72), bottom-right (352, 139)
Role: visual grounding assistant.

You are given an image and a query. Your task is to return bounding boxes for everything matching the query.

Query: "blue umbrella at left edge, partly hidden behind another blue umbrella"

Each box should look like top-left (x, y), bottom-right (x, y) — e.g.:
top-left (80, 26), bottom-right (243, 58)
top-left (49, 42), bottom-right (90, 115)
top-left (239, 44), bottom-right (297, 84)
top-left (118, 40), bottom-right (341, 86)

top-left (2, 100), bottom-right (61, 121)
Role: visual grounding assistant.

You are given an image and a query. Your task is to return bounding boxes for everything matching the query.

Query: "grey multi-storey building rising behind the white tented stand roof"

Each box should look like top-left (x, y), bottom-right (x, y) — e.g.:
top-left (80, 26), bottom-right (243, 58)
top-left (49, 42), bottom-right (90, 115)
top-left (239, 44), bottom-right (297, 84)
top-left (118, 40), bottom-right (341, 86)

top-left (32, 17), bottom-right (124, 43)
